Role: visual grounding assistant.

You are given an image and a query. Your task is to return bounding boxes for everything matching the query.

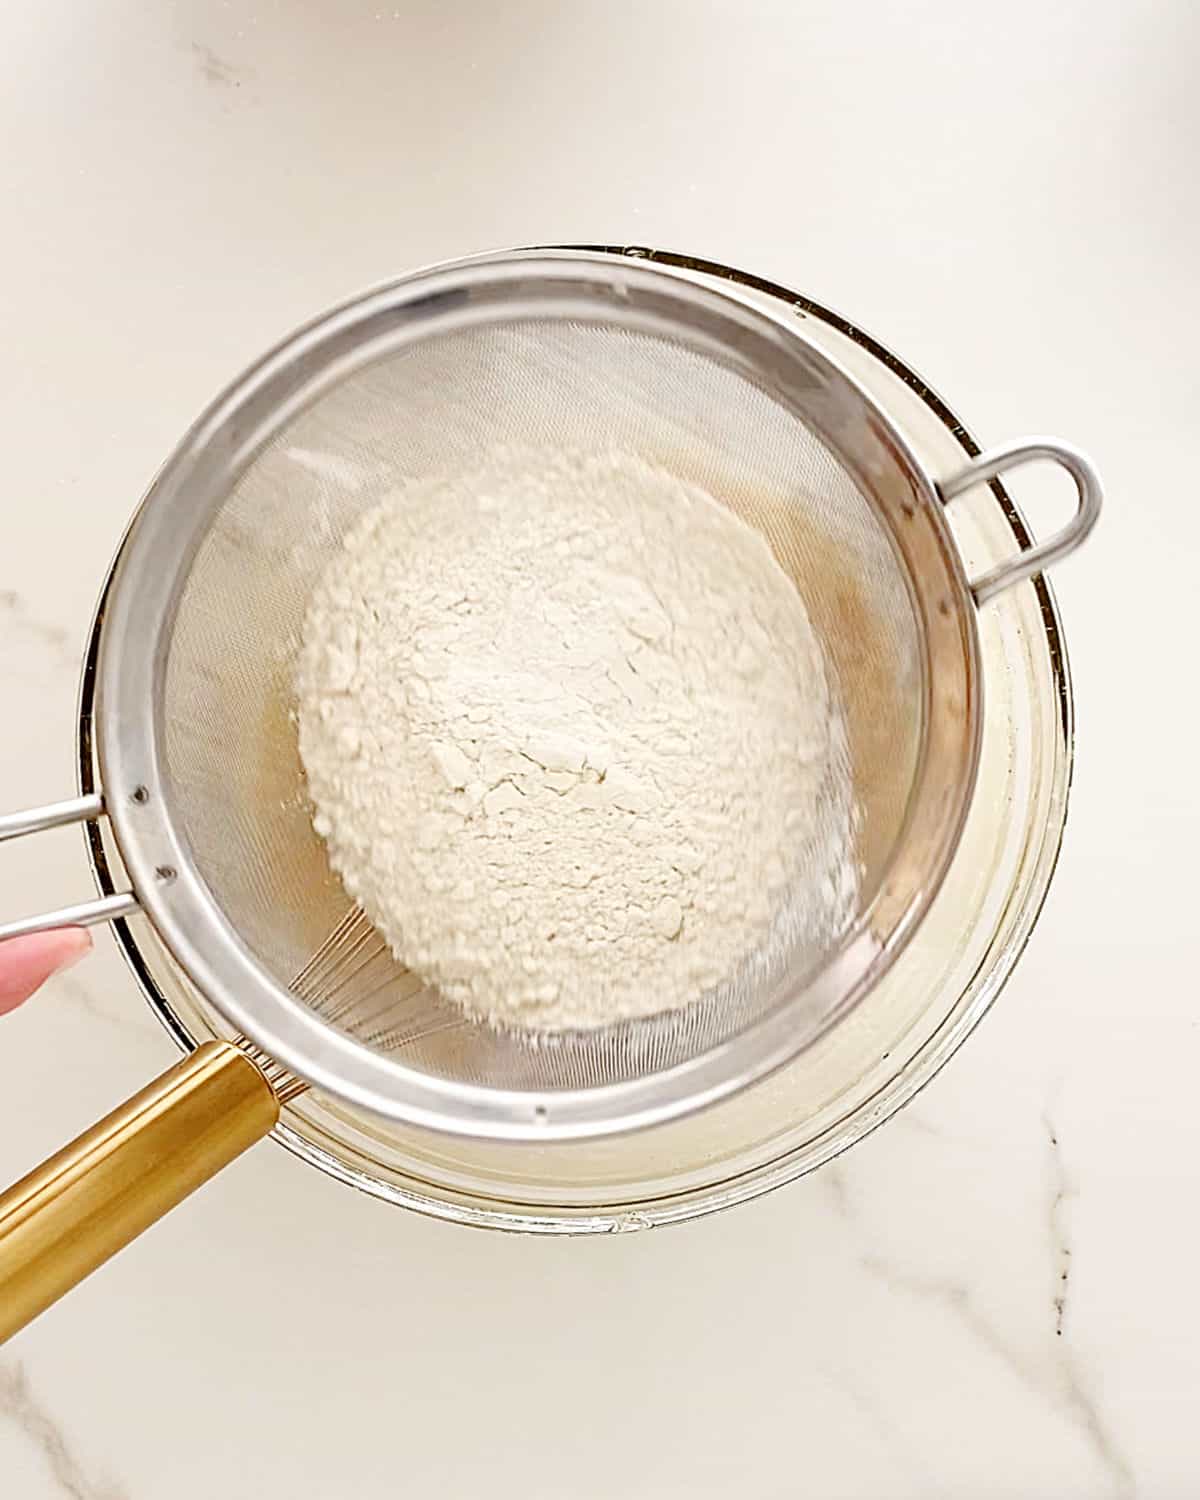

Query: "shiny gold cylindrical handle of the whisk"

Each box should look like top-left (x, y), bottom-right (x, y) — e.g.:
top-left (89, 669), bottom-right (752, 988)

top-left (0, 1041), bottom-right (279, 1343)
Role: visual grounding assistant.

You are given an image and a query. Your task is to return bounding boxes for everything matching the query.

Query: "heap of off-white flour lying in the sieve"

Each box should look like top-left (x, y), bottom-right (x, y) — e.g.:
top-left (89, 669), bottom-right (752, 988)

top-left (297, 450), bottom-right (857, 1031)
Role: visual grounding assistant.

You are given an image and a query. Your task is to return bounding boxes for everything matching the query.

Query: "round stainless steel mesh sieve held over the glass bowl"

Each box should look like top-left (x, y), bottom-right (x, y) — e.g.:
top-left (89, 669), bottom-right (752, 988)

top-left (0, 252), bottom-right (1100, 1140)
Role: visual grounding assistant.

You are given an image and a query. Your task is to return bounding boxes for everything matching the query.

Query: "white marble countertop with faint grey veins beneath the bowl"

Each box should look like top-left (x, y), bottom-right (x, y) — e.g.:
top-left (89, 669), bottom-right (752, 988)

top-left (0, 0), bottom-right (1200, 1500)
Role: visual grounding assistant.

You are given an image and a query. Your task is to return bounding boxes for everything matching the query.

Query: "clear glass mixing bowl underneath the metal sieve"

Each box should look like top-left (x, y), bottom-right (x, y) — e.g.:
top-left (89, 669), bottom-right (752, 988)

top-left (80, 246), bottom-right (1073, 1233)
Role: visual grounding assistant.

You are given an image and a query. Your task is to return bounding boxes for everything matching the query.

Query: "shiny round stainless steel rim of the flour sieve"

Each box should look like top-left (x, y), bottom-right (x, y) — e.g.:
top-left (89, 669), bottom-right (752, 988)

top-left (89, 255), bottom-right (978, 1139)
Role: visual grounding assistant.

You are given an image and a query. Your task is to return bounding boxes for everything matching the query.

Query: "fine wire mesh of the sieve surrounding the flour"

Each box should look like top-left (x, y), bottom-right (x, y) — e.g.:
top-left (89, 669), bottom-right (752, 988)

top-left (162, 320), bottom-right (923, 1089)
